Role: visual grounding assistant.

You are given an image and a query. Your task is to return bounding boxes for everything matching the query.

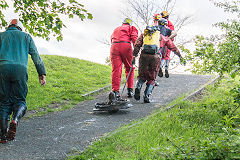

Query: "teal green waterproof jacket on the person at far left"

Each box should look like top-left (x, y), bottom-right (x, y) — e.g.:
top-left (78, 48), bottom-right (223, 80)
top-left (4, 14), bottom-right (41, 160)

top-left (0, 27), bottom-right (46, 75)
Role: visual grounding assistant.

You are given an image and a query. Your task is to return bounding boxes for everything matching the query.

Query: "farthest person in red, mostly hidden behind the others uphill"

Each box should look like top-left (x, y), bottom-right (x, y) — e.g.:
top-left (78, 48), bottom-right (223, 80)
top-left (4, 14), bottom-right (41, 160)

top-left (158, 11), bottom-right (174, 78)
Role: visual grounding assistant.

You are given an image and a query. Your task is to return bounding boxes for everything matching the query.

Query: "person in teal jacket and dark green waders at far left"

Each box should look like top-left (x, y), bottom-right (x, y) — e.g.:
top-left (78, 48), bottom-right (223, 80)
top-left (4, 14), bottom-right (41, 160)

top-left (0, 19), bottom-right (46, 143)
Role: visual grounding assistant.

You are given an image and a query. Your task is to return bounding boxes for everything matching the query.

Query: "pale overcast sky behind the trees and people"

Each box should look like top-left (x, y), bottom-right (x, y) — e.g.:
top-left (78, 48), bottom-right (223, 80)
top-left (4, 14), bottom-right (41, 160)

top-left (1, 0), bottom-right (234, 64)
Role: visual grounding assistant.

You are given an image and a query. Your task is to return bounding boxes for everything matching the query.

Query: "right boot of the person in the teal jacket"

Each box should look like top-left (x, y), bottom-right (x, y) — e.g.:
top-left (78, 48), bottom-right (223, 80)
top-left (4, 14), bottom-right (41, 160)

top-left (7, 106), bottom-right (27, 141)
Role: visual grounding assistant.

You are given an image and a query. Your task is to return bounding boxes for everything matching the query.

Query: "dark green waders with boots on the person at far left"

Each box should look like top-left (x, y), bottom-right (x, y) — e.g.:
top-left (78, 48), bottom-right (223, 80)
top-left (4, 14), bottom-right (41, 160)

top-left (0, 64), bottom-right (28, 142)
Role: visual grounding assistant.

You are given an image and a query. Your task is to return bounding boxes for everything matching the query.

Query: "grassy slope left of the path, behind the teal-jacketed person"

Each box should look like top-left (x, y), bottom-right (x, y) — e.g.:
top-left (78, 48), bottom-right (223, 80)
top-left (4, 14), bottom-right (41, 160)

top-left (27, 55), bottom-right (111, 115)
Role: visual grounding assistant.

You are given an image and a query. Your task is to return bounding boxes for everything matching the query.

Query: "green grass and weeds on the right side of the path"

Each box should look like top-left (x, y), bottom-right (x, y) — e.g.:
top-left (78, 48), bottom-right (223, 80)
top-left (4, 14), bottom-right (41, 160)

top-left (69, 75), bottom-right (240, 160)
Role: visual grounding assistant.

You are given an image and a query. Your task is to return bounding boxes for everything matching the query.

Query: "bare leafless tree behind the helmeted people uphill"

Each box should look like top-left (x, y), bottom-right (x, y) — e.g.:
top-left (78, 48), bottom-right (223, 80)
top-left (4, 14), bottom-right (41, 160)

top-left (122, 0), bottom-right (192, 32)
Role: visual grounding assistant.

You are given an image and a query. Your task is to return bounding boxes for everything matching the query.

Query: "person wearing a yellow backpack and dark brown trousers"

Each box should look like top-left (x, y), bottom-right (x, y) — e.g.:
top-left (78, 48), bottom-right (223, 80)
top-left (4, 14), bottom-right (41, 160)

top-left (133, 26), bottom-right (182, 103)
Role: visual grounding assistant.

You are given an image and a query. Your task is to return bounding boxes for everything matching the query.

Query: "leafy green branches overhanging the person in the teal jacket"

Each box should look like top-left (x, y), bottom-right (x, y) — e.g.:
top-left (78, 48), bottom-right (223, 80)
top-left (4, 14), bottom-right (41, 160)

top-left (0, 0), bottom-right (92, 41)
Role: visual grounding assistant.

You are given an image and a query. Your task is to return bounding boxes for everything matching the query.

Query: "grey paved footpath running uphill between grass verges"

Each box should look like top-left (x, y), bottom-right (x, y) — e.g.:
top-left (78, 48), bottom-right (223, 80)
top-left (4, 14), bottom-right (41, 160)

top-left (0, 74), bottom-right (211, 160)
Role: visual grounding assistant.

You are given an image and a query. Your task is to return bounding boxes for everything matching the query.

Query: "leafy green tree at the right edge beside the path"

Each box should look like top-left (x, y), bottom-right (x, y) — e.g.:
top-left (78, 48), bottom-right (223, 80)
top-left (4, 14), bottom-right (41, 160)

top-left (185, 0), bottom-right (240, 75)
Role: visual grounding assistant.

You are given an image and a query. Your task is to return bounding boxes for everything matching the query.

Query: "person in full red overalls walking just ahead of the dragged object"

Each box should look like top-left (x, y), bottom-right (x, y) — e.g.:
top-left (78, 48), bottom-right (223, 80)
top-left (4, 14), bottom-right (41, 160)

top-left (110, 18), bottom-right (138, 98)
